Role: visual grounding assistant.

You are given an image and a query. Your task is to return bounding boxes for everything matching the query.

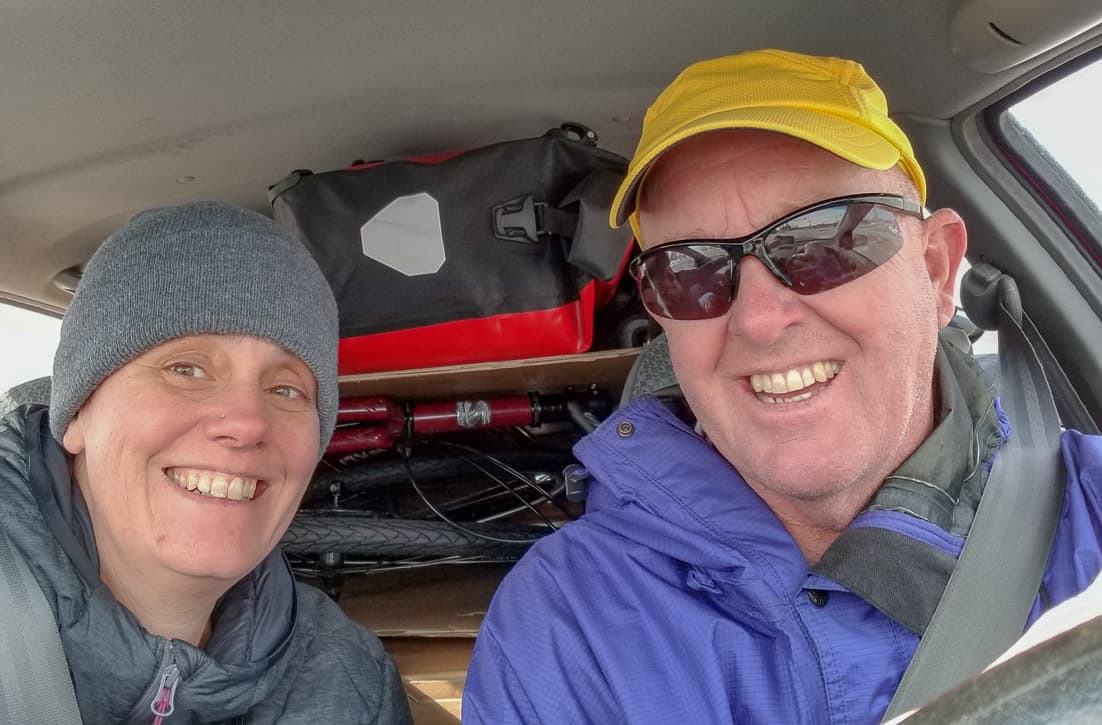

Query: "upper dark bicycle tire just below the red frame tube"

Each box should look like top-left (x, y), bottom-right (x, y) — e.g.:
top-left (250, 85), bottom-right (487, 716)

top-left (303, 447), bottom-right (576, 506)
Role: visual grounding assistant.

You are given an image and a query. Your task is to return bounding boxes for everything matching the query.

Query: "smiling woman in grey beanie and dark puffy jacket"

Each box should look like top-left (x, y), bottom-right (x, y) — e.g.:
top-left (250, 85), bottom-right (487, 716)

top-left (0, 203), bottom-right (409, 725)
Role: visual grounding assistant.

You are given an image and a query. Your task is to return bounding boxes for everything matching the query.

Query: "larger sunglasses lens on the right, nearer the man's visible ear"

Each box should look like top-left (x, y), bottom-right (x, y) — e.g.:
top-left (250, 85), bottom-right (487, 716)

top-left (765, 203), bottom-right (903, 294)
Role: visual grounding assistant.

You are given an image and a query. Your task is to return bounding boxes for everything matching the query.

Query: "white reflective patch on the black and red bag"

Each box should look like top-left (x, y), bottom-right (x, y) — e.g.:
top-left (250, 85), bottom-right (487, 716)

top-left (359, 192), bottom-right (445, 277)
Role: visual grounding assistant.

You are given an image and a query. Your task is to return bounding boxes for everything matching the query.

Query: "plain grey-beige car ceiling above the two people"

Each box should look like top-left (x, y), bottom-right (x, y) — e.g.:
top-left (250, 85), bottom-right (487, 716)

top-left (0, 0), bottom-right (1102, 311)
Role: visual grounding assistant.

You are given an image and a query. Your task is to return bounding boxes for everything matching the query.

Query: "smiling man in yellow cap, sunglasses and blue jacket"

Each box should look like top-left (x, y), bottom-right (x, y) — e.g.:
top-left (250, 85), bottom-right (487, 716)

top-left (464, 51), bottom-right (1102, 724)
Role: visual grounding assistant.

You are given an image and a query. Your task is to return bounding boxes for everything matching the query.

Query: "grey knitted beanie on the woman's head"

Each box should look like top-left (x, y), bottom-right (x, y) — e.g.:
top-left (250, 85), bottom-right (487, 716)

top-left (50, 202), bottom-right (338, 455)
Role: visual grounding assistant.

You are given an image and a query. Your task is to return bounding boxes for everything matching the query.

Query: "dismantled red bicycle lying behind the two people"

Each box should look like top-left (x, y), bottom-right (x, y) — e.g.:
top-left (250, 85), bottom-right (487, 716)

top-left (282, 386), bottom-right (611, 597)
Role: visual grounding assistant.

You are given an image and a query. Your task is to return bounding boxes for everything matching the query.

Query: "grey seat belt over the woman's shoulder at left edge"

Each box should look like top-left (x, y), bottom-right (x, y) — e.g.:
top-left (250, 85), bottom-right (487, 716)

top-left (0, 530), bottom-right (80, 725)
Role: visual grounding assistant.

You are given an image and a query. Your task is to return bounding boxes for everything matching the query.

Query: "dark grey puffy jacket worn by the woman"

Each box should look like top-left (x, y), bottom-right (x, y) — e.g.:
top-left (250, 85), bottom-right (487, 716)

top-left (0, 407), bottom-right (410, 725)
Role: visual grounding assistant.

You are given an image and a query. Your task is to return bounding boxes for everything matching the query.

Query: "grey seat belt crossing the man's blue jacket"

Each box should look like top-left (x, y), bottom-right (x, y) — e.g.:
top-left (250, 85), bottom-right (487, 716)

top-left (884, 263), bottom-right (1065, 719)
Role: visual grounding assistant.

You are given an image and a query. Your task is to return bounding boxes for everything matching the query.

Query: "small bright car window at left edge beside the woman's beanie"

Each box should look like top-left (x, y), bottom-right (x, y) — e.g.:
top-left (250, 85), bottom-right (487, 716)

top-left (0, 303), bottom-right (62, 391)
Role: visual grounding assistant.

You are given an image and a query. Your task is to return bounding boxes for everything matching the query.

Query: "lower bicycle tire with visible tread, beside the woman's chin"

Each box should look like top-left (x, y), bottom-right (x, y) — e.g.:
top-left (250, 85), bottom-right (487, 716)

top-left (281, 510), bottom-right (550, 559)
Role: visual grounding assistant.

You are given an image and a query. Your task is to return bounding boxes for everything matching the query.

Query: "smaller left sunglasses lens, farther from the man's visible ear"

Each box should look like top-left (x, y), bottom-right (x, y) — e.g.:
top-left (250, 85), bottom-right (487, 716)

top-left (635, 245), bottom-right (736, 320)
